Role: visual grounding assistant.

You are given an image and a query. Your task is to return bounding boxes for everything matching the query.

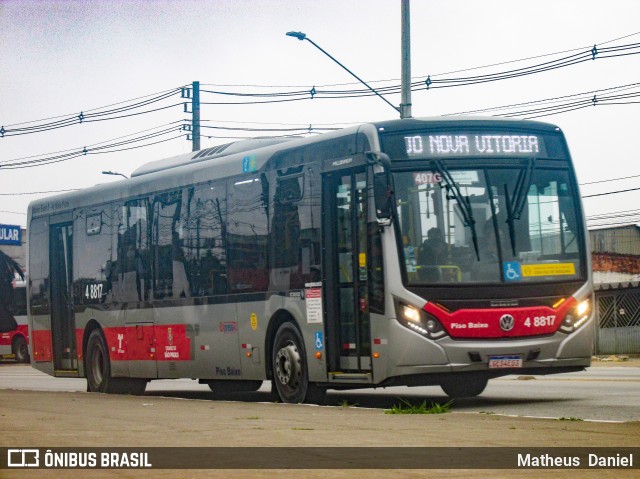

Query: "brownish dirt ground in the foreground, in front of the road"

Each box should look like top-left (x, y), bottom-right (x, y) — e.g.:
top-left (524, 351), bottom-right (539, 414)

top-left (0, 390), bottom-right (640, 479)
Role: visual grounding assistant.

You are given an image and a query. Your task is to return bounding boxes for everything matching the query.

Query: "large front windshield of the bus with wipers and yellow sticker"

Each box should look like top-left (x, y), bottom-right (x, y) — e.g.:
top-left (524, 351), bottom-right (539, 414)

top-left (394, 165), bottom-right (584, 284)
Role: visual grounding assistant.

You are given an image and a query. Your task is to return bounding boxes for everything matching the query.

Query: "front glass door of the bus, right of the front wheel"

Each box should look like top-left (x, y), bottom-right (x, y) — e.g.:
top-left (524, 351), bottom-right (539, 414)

top-left (323, 168), bottom-right (371, 373)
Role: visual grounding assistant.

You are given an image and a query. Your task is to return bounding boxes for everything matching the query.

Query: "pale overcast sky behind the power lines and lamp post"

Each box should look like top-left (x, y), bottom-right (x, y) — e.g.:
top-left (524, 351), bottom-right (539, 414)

top-left (0, 0), bottom-right (640, 226)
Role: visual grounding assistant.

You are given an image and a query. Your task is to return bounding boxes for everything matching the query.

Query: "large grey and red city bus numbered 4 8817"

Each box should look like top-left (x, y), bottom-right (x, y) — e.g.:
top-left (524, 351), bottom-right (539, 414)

top-left (28, 118), bottom-right (594, 403)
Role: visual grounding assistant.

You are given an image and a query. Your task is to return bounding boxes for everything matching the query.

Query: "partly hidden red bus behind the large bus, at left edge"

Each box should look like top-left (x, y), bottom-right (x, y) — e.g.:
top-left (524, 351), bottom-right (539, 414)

top-left (0, 280), bottom-right (29, 363)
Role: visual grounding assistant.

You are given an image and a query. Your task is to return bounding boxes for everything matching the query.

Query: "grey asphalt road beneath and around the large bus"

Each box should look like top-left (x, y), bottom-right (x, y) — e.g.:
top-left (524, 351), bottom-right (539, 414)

top-left (0, 361), bottom-right (640, 422)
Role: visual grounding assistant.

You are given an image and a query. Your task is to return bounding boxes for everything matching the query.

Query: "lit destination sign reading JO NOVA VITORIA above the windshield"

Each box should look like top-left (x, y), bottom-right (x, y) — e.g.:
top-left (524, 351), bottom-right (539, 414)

top-left (404, 134), bottom-right (547, 158)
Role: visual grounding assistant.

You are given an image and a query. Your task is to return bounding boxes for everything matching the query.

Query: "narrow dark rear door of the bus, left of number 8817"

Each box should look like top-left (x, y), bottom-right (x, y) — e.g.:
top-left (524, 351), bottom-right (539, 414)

top-left (49, 221), bottom-right (78, 372)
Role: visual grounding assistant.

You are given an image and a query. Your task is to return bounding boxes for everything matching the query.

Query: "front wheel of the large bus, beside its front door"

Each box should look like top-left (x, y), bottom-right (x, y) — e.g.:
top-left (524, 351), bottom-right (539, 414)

top-left (272, 322), bottom-right (325, 403)
